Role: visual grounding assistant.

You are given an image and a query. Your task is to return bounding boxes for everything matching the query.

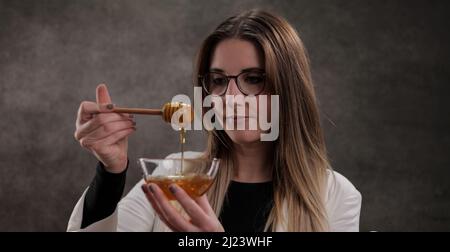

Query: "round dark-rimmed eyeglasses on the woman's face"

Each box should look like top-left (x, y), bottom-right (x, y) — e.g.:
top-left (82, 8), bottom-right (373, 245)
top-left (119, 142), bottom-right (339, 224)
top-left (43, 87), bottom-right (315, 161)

top-left (198, 70), bottom-right (266, 96)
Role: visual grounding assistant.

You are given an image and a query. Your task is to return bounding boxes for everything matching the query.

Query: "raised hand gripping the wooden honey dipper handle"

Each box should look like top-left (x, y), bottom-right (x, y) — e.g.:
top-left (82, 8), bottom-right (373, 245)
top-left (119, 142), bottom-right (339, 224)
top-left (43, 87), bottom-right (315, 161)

top-left (74, 84), bottom-right (136, 173)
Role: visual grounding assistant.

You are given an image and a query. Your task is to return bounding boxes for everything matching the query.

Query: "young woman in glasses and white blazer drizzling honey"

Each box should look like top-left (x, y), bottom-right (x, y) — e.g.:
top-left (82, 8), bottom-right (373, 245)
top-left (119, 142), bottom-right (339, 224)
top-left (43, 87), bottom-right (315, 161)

top-left (68, 10), bottom-right (361, 231)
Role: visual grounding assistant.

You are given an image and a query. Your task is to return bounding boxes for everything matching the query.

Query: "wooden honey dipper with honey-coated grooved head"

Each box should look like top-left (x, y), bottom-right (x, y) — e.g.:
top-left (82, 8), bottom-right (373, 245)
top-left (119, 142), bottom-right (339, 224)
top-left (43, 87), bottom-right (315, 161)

top-left (112, 102), bottom-right (194, 123)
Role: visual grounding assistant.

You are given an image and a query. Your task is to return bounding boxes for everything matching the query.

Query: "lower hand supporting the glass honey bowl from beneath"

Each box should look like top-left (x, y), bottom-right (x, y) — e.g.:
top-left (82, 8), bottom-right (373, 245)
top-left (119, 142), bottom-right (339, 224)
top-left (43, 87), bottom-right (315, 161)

top-left (142, 183), bottom-right (224, 232)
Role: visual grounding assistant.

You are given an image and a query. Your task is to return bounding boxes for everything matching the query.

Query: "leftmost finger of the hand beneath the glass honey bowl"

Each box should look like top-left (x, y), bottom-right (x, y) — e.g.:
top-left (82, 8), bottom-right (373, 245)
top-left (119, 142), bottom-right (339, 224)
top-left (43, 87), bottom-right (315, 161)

top-left (149, 184), bottom-right (198, 232)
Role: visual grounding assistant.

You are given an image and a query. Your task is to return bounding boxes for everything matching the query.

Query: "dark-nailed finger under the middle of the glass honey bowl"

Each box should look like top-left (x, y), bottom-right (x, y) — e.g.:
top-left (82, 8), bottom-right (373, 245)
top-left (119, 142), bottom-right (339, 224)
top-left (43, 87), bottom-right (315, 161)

top-left (169, 184), bottom-right (208, 226)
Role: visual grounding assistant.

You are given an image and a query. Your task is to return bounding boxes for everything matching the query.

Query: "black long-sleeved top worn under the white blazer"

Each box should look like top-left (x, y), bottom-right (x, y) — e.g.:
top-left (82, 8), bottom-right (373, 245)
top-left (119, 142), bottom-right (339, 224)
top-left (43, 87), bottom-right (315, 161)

top-left (81, 162), bottom-right (273, 232)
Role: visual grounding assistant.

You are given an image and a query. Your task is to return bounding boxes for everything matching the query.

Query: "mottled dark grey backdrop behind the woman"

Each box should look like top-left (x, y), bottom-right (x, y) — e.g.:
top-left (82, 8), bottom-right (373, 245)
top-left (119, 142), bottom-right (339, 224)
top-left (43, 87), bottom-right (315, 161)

top-left (0, 0), bottom-right (450, 231)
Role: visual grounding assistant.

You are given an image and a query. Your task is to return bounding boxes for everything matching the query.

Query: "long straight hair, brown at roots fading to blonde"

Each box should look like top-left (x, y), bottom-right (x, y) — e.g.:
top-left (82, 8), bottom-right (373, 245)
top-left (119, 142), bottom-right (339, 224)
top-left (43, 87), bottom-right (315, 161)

top-left (194, 10), bottom-right (329, 231)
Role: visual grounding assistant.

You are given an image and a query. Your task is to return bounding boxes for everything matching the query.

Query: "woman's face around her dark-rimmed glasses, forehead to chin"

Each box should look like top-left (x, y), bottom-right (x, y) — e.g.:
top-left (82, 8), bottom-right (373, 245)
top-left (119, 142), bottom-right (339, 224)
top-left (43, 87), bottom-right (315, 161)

top-left (210, 39), bottom-right (270, 144)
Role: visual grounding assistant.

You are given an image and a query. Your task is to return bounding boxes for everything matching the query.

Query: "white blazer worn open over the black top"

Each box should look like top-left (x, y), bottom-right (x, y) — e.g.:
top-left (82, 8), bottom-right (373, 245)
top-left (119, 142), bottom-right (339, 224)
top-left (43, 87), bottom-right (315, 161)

top-left (67, 152), bottom-right (361, 232)
